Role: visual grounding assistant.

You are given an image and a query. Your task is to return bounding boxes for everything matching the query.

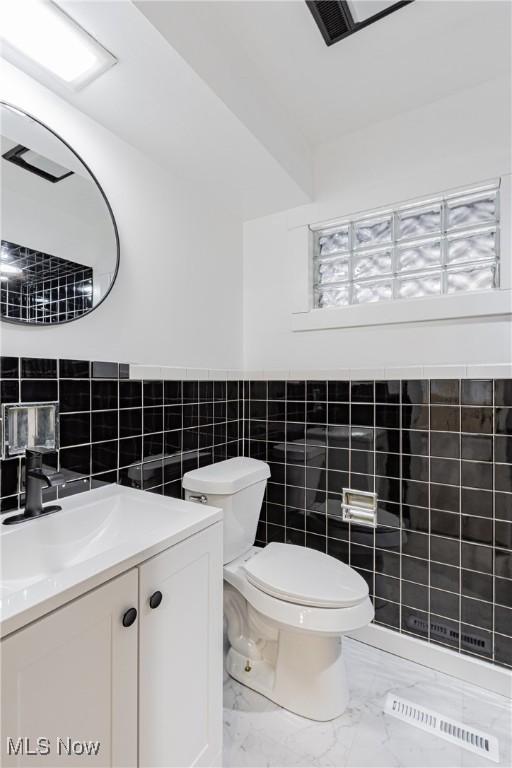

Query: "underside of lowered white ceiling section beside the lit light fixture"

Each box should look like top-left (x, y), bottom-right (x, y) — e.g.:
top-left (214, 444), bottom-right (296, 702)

top-left (31, 0), bottom-right (312, 218)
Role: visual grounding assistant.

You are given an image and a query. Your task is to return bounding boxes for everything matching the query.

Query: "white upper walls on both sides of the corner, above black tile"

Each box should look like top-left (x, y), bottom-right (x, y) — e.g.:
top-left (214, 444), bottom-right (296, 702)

top-left (0, 65), bottom-right (512, 369)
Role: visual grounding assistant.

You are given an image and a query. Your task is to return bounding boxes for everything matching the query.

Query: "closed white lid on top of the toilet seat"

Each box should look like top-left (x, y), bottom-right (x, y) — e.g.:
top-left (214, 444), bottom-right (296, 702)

top-left (244, 542), bottom-right (368, 608)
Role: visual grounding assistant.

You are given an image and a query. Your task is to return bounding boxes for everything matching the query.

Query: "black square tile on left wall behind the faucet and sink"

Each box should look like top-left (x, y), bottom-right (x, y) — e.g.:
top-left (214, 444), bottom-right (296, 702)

top-left (0, 357), bottom-right (243, 511)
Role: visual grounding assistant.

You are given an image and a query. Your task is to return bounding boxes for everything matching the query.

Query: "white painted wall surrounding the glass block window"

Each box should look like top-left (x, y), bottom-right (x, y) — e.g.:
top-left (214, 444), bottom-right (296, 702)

top-left (244, 75), bottom-right (512, 370)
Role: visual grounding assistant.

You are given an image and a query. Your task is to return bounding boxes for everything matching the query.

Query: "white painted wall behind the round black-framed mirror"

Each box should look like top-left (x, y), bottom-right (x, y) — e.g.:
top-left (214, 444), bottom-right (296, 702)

top-left (0, 63), bottom-right (242, 368)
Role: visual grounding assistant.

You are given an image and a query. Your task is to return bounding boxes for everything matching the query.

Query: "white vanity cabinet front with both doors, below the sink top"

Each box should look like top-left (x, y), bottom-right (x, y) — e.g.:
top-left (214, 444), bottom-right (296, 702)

top-left (1, 523), bottom-right (222, 768)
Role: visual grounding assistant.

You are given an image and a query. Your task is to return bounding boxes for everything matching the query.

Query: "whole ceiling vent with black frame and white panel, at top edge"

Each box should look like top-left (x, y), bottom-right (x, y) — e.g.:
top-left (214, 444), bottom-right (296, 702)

top-left (306, 0), bottom-right (413, 45)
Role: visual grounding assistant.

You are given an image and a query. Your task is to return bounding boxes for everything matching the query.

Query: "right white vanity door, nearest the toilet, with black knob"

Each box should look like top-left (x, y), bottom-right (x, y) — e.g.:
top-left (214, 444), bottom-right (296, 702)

top-left (139, 523), bottom-right (222, 768)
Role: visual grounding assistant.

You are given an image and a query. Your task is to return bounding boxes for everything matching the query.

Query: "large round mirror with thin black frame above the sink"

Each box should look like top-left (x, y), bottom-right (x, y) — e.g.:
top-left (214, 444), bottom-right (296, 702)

top-left (0, 104), bottom-right (119, 325)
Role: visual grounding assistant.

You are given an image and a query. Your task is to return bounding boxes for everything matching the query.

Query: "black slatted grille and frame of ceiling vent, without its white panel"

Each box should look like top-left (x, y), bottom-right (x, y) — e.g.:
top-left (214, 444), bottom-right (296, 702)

top-left (306, 0), bottom-right (414, 45)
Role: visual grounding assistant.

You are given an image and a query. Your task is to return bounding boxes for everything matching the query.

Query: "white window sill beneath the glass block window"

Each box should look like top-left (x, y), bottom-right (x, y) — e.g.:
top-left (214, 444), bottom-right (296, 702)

top-left (291, 290), bottom-right (512, 331)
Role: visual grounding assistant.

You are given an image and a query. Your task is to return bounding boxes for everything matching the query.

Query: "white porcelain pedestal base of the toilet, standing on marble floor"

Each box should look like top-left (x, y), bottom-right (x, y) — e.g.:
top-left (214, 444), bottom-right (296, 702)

top-left (226, 629), bottom-right (349, 721)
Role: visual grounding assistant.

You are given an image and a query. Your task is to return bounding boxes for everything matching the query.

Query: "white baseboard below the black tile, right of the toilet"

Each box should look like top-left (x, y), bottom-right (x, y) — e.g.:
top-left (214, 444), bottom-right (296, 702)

top-left (347, 624), bottom-right (512, 699)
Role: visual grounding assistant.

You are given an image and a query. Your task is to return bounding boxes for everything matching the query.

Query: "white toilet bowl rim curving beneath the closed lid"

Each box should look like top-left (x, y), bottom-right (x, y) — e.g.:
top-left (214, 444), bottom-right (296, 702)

top-left (224, 544), bottom-right (373, 635)
